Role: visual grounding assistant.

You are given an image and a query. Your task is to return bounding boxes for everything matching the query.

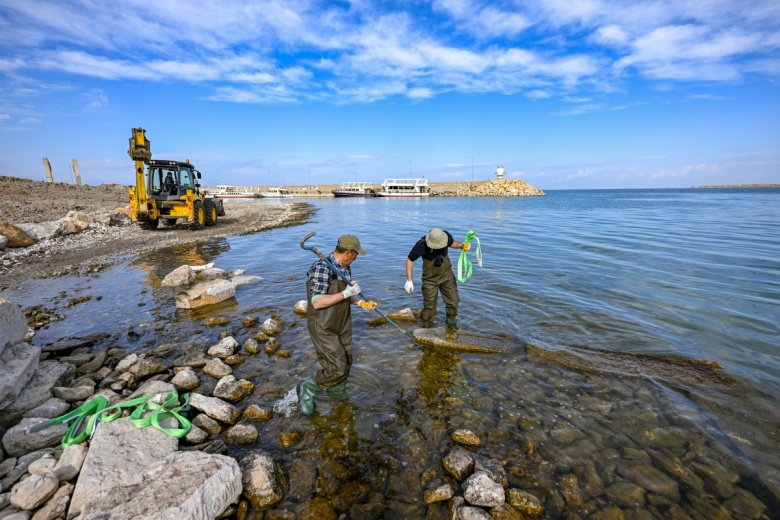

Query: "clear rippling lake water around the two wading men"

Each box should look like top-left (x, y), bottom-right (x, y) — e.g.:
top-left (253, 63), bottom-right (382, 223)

top-left (2, 189), bottom-right (780, 518)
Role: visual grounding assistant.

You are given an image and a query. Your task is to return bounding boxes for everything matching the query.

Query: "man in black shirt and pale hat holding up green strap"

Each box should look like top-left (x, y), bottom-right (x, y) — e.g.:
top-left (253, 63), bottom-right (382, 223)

top-left (404, 228), bottom-right (469, 329)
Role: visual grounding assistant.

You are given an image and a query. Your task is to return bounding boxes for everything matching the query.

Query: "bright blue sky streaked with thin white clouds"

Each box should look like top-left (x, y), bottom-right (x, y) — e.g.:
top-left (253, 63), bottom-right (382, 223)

top-left (0, 0), bottom-right (780, 190)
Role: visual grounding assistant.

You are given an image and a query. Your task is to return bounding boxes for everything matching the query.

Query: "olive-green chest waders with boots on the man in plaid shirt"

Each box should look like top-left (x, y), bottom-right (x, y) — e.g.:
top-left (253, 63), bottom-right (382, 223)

top-left (298, 275), bottom-right (352, 415)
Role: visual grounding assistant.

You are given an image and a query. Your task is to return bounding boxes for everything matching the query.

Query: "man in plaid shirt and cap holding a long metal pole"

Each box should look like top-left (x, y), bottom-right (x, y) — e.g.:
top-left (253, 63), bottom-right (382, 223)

top-left (297, 235), bottom-right (376, 415)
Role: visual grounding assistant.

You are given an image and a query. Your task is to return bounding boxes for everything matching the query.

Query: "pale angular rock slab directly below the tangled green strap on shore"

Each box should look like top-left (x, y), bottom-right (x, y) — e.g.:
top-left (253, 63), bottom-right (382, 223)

top-left (68, 417), bottom-right (179, 520)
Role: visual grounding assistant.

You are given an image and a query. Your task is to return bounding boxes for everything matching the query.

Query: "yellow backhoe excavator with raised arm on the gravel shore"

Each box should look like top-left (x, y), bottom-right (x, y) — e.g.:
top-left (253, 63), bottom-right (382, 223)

top-left (127, 128), bottom-right (225, 229)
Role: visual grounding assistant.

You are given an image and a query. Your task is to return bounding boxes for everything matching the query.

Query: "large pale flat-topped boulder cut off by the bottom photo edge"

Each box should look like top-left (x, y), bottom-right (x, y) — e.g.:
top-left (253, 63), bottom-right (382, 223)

top-left (79, 451), bottom-right (241, 520)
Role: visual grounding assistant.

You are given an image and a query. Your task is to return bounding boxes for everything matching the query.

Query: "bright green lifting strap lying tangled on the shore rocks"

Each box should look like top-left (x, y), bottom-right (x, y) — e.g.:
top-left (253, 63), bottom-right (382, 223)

top-left (25, 392), bottom-right (192, 449)
